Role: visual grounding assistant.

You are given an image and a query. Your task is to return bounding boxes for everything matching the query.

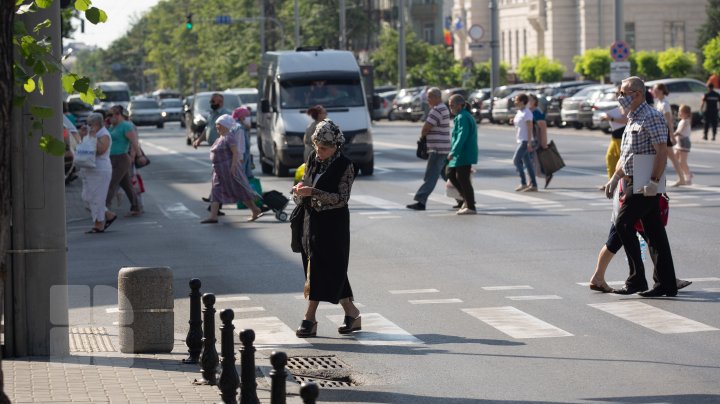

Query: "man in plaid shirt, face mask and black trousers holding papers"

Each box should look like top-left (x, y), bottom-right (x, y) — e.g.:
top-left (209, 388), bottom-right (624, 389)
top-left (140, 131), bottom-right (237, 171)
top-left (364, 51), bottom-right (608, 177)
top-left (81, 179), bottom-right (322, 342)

top-left (605, 76), bottom-right (678, 297)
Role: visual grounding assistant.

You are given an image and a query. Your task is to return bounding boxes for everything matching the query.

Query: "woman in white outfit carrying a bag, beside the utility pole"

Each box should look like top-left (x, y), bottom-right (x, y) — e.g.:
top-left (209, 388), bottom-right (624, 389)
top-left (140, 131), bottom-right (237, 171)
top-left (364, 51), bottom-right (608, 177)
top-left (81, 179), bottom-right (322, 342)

top-left (80, 113), bottom-right (117, 233)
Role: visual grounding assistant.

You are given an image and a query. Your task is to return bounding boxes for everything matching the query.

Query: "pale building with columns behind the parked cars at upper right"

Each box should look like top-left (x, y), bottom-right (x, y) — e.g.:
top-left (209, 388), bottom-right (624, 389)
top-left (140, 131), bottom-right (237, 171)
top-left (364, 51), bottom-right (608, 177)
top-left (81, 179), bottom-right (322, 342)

top-left (452, 0), bottom-right (707, 77)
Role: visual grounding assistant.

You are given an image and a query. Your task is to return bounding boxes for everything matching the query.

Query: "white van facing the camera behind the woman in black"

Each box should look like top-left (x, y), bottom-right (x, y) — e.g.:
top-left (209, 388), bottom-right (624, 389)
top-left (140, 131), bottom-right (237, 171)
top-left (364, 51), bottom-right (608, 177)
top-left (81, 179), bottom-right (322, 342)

top-left (257, 48), bottom-right (374, 177)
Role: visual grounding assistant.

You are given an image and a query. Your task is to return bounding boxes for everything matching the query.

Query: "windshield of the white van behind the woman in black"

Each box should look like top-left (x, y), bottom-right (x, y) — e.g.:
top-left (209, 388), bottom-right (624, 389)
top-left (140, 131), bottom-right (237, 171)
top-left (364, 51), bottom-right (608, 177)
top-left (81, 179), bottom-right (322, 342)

top-left (280, 77), bottom-right (365, 108)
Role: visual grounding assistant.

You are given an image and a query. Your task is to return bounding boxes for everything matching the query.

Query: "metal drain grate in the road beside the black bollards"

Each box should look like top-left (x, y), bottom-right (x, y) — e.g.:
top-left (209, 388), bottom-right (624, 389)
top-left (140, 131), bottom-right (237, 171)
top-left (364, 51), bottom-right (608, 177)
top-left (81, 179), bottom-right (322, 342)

top-left (287, 355), bottom-right (357, 388)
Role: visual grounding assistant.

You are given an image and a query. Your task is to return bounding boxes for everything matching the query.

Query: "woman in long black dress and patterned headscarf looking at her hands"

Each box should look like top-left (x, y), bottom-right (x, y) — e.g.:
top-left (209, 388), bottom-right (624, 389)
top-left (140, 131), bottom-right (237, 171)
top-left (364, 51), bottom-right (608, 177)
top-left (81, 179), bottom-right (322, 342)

top-left (293, 119), bottom-right (361, 338)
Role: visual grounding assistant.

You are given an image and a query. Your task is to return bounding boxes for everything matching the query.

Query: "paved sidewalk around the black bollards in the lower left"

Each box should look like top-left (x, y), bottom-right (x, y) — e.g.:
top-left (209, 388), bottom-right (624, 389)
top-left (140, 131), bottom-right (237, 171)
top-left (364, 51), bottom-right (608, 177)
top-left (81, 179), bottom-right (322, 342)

top-left (2, 179), bottom-right (302, 403)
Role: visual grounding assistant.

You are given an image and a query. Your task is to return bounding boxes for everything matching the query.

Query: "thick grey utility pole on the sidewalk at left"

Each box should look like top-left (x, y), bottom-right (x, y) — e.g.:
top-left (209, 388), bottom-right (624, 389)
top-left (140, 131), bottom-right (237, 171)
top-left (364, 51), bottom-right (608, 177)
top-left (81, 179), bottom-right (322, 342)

top-left (5, 2), bottom-right (69, 356)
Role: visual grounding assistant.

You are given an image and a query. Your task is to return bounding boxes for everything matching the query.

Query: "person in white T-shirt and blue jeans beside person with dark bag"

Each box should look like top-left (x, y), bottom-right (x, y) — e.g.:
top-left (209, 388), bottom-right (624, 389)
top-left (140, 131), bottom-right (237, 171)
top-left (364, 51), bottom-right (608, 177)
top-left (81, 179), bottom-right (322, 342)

top-left (513, 93), bottom-right (537, 192)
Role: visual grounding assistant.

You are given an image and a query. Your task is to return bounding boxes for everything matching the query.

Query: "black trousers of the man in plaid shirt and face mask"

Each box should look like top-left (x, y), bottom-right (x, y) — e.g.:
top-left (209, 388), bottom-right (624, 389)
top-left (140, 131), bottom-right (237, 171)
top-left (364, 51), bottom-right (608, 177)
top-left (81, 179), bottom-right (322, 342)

top-left (615, 184), bottom-right (677, 292)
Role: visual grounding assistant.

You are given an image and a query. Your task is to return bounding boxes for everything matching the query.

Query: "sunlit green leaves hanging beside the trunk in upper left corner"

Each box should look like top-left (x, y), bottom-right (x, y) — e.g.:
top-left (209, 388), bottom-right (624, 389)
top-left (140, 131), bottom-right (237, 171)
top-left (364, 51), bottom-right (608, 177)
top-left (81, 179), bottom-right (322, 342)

top-left (13, 0), bottom-right (107, 156)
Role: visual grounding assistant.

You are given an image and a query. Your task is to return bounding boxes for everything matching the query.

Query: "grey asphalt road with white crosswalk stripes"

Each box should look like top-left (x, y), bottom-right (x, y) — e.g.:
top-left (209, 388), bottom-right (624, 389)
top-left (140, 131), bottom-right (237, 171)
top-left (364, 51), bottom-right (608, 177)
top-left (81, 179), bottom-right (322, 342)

top-left (68, 118), bottom-right (720, 403)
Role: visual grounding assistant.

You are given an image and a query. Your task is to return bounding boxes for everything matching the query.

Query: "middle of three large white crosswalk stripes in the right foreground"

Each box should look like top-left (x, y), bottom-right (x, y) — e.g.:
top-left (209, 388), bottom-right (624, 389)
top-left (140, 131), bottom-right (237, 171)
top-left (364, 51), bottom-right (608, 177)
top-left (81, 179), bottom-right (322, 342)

top-left (462, 306), bottom-right (573, 338)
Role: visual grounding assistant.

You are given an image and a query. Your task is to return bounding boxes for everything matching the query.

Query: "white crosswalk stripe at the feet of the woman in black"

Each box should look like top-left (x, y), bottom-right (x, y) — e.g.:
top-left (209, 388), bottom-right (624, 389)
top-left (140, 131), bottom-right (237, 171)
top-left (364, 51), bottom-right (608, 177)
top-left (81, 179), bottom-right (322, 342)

top-left (326, 313), bottom-right (423, 345)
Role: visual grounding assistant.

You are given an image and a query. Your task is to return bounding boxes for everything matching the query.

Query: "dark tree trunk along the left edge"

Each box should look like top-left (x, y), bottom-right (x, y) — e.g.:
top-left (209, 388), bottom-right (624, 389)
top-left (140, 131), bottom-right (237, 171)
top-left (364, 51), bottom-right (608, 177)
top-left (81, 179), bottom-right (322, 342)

top-left (0, 1), bottom-right (15, 403)
